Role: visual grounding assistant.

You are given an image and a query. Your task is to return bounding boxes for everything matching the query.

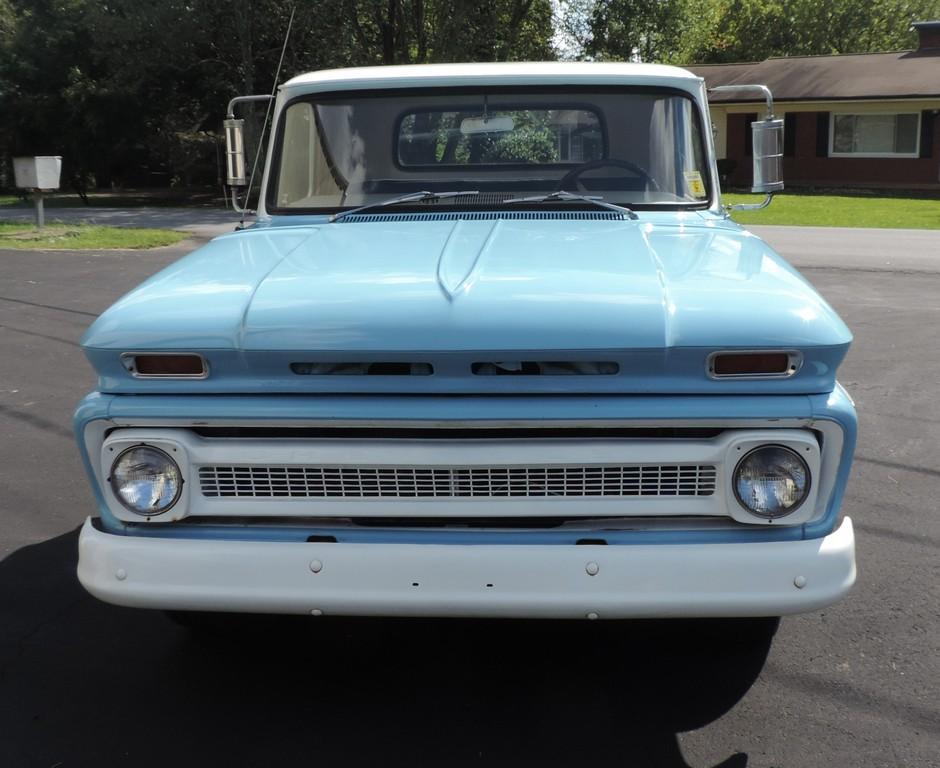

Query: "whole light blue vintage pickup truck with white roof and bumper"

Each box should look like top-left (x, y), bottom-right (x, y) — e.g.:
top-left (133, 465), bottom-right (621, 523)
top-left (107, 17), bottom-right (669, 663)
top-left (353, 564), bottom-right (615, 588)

top-left (75, 63), bottom-right (856, 619)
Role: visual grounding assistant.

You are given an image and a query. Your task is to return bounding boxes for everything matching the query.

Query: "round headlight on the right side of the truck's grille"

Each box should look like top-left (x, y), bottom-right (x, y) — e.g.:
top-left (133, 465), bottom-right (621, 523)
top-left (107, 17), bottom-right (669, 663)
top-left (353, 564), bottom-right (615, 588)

top-left (733, 445), bottom-right (810, 518)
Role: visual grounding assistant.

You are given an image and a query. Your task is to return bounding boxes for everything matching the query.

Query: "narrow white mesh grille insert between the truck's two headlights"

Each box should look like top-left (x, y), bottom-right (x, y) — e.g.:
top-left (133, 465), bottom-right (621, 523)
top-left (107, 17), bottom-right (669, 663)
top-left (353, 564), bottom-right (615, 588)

top-left (199, 464), bottom-right (716, 499)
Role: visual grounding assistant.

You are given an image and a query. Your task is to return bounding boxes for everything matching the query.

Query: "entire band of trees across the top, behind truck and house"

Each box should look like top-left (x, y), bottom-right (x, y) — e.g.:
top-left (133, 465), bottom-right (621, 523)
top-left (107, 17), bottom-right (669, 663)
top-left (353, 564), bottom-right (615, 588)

top-left (0, 0), bottom-right (940, 188)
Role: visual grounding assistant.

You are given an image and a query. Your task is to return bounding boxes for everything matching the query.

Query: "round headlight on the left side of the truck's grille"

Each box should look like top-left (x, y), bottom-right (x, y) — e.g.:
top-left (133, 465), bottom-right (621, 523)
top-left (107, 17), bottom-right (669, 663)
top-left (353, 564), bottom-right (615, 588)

top-left (110, 445), bottom-right (183, 517)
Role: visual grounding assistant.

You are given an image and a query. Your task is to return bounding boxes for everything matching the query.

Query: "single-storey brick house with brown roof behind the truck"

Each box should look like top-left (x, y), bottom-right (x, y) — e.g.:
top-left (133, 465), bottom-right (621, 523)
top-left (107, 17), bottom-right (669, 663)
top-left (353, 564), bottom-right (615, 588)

top-left (689, 21), bottom-right (940, 190)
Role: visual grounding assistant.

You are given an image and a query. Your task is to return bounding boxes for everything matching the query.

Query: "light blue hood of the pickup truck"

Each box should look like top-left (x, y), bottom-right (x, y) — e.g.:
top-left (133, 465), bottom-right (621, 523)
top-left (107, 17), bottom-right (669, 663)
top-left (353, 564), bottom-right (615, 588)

top-left (82, 217), bottom-right (851, 392)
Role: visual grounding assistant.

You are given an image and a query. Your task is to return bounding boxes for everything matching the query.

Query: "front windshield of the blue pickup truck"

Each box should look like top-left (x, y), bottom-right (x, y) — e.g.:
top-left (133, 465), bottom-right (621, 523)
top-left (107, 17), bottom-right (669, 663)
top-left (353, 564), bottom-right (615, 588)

top-left (267, 87), bottom-right (710, 213)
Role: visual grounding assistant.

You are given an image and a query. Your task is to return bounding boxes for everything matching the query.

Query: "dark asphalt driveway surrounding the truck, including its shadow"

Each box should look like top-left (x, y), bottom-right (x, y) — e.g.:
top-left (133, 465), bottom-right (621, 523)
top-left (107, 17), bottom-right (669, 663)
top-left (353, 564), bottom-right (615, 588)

top-left (0, 231), bottom-right (940, 768)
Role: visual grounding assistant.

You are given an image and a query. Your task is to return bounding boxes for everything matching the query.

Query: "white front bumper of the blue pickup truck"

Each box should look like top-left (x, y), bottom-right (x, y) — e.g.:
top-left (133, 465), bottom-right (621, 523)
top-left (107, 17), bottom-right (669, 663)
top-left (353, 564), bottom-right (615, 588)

top-left (78, 518), bottom-right (855, 618)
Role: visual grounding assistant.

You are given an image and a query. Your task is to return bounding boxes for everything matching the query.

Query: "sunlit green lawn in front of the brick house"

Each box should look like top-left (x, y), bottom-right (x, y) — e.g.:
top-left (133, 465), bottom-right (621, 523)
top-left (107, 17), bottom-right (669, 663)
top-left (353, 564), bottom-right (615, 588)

top-left (721, 193), bottom-right (940, 229)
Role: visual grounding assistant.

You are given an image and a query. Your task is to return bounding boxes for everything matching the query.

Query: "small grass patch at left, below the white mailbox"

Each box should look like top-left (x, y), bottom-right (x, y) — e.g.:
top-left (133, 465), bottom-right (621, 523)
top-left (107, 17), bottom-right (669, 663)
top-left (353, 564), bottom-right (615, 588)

top-left (0, 222), bottom-right (189, 251)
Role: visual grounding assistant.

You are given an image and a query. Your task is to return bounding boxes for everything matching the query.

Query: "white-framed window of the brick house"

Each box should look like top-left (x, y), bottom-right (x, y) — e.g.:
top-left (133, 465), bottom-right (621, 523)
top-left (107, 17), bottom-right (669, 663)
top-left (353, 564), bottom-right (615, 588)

top-left (829, 112), bottom-right (920, 157)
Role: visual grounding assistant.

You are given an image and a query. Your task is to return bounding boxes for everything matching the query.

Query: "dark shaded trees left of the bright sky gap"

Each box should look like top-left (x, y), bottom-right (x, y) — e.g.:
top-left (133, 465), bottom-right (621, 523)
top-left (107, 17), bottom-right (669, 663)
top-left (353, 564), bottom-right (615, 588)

top-left (0, 0), bottom-right (553, 187)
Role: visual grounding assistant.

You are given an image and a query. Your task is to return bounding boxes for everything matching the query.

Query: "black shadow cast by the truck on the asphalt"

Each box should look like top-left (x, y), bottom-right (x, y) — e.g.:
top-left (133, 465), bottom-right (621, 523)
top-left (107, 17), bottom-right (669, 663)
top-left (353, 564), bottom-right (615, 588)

top-left (0, 531), bottom-right (774, 768)
